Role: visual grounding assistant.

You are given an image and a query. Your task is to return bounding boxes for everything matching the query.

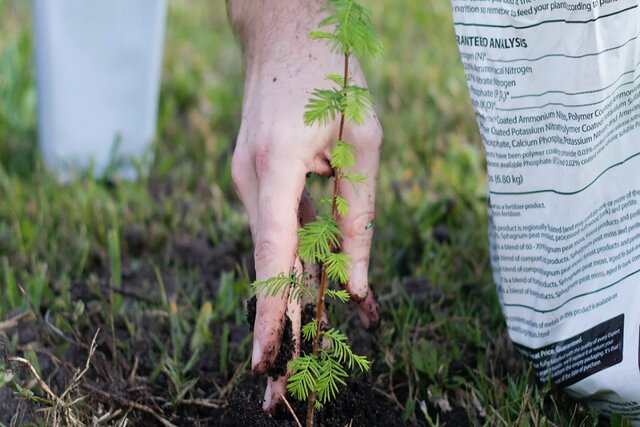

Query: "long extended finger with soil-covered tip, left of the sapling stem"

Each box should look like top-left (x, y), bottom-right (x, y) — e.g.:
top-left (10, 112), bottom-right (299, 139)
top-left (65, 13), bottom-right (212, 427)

top-left (251, 156), bottom-right (305, 373)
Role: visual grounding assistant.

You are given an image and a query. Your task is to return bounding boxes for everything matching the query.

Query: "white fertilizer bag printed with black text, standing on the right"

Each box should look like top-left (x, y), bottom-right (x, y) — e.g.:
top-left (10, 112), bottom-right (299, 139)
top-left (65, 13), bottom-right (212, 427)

top-left (452, 0), bottom-right (640, 426)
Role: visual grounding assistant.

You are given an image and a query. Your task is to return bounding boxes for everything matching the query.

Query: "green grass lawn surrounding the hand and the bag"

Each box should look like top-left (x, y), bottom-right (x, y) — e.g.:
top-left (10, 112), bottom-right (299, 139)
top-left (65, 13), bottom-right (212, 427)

top-left (0, 0), bottom-right (624, 426)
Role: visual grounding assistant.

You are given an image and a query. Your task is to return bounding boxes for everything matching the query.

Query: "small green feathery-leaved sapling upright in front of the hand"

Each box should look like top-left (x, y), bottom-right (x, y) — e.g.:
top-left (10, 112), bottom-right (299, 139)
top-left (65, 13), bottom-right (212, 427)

top-left (252, 0), bottom-right (383, 427)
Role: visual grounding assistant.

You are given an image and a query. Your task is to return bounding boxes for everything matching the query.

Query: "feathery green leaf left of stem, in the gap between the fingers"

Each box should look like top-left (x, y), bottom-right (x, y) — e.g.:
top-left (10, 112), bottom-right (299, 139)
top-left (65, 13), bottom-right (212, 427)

top-left (298, 216), bottom-right (342, 264)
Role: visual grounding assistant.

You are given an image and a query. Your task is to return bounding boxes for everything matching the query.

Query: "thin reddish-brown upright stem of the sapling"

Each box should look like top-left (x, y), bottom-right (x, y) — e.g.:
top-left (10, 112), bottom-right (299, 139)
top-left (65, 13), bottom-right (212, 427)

top-left (306, 53), bottom-right (349, 427)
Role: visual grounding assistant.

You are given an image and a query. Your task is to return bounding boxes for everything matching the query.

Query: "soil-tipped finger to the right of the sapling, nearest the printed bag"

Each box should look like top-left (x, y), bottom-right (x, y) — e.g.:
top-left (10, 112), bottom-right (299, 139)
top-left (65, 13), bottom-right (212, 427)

top-left (338, 120), bottom-right (382, 328)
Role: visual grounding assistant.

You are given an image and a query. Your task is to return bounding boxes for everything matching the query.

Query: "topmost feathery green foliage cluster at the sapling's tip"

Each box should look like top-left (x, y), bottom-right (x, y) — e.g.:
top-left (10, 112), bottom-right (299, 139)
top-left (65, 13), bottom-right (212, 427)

top-left (309, 0), bottom-right (384, 58)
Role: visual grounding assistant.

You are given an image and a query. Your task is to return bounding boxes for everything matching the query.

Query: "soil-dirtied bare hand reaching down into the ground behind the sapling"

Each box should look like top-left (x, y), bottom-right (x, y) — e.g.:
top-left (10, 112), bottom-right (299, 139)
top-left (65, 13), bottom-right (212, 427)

top-left (231, 1), bottom-right (382, 409)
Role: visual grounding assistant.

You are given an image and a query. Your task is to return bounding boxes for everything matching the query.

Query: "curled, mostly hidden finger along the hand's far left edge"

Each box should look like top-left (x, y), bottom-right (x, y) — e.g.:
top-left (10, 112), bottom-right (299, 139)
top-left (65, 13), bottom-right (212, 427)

top-left (231, 140), bottom-right (258, 241)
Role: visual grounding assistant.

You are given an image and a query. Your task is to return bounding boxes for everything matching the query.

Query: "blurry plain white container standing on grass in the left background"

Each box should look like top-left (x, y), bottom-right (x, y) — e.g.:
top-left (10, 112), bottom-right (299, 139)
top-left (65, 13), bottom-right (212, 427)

top-left (33, 0), bottom-right (167, 179)
